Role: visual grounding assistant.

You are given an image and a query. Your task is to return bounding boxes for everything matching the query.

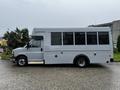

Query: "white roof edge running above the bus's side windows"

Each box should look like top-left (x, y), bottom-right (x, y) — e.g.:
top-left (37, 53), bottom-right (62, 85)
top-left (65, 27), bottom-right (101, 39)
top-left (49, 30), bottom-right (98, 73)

top-left (32, 27), bottom-right (111, 34)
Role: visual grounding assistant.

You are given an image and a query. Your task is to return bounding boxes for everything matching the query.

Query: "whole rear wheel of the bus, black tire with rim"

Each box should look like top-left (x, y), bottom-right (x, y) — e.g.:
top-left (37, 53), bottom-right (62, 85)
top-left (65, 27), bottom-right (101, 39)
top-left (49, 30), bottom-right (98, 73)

top-left (76, 57), bottom-right (88, 68)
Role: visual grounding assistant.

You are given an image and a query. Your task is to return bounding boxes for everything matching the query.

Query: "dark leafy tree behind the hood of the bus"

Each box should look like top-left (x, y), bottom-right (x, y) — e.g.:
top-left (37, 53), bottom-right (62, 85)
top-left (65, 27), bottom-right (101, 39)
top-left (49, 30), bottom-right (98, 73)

top-left (4, 28), bottom-right (29, 49)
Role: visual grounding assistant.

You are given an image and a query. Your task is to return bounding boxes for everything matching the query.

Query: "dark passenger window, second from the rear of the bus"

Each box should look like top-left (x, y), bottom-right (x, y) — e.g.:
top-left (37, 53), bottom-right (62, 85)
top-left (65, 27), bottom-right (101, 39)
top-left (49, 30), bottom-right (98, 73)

top-left (87, 32), bottom-right (97, 45)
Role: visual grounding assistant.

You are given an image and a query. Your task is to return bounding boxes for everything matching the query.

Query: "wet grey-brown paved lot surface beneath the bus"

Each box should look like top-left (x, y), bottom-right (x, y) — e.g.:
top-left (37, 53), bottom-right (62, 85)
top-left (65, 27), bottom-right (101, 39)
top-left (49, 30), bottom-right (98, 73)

top-left (0, 60), bottom-right (120, 90)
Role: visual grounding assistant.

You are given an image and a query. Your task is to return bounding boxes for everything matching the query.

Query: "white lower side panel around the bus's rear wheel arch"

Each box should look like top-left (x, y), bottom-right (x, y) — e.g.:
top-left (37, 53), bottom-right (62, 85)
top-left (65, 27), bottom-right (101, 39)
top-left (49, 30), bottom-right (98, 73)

top-left (44, 51), bottom-right (112, 64)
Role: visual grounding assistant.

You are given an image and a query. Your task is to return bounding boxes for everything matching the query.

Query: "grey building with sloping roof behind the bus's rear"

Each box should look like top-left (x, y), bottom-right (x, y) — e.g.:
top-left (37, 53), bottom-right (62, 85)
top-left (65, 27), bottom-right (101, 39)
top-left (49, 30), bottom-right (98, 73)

top-left (89, 20), bottom-right (120, 48)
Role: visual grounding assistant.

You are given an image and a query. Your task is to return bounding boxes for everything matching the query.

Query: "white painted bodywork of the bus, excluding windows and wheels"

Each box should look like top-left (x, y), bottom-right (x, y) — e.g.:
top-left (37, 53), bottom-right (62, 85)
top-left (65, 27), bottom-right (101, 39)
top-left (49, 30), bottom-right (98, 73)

top-left (13, 27), bottom-right (113, 64)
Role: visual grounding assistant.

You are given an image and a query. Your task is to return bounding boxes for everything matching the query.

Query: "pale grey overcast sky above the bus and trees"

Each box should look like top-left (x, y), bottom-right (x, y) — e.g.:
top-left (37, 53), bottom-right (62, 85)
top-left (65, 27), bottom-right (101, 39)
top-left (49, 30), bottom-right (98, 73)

top-left (0, 0), bottom-right (120, 36)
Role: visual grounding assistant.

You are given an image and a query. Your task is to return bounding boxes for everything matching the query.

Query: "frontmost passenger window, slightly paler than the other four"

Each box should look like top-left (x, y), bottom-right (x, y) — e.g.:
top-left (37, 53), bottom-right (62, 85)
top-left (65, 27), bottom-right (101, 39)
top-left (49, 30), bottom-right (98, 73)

top-left (51, 32), bottom-right (62, 45)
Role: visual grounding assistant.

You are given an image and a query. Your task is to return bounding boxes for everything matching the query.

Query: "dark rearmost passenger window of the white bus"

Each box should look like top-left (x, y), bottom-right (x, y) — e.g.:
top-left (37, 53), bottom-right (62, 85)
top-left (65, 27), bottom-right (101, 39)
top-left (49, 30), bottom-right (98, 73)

top-left (98, 32), bottom-right (109, 44)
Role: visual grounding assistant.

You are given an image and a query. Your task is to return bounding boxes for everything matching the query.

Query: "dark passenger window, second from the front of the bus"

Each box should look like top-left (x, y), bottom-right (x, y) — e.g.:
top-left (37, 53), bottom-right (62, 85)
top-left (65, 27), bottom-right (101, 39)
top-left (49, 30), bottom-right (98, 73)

top-left (63, 32), bottom-right (73, 45)
